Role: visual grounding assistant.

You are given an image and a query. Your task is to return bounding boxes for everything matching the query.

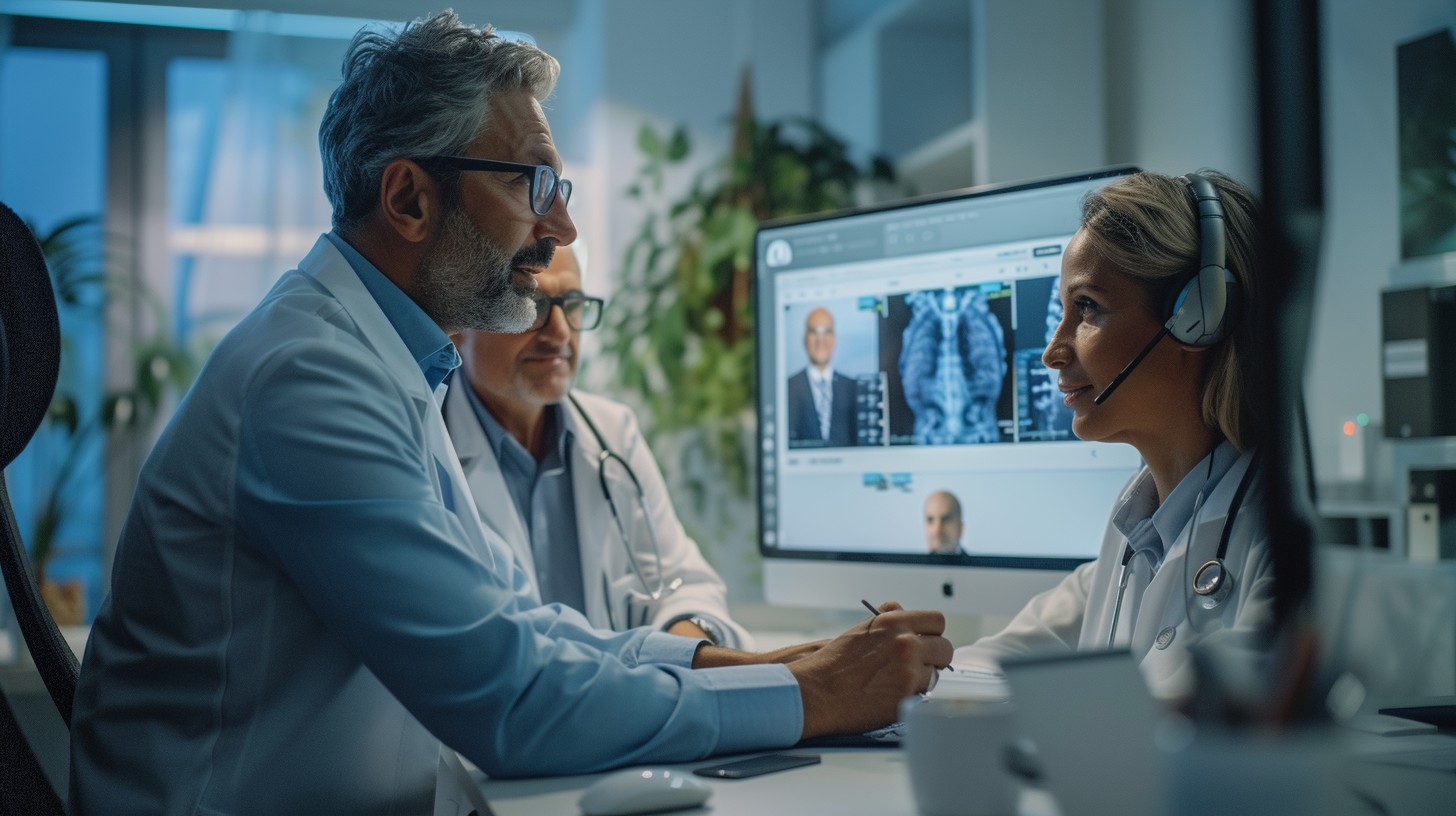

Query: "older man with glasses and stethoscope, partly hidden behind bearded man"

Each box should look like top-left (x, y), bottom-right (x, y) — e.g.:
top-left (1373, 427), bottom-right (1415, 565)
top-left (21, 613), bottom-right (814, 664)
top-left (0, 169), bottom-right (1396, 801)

top-left (444, 246), bottom-right (751, 648)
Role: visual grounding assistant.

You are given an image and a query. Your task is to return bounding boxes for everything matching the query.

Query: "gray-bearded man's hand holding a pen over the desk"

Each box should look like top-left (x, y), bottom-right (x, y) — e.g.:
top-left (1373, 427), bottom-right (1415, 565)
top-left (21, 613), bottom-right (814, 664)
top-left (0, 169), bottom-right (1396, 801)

top-left (788, 602), bottom-right (952, 739)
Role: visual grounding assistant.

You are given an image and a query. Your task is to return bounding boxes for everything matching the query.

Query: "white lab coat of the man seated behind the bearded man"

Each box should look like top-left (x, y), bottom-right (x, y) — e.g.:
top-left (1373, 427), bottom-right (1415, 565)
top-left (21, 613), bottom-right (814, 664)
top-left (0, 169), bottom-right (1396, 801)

top-left (444, 376), bottom-right (753, 648)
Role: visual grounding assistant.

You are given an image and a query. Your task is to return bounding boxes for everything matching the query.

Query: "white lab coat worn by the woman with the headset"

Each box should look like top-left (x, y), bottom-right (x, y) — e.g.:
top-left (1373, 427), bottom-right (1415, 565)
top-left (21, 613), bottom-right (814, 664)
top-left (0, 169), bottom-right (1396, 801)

top-left (955, 450), bottom-right (1274, 698)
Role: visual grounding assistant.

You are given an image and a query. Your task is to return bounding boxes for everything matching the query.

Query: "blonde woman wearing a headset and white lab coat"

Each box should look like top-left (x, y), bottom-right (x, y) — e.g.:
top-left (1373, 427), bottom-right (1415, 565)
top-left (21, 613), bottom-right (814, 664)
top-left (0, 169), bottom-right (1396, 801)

top-left (954, 170), bottom-right (1273, 698)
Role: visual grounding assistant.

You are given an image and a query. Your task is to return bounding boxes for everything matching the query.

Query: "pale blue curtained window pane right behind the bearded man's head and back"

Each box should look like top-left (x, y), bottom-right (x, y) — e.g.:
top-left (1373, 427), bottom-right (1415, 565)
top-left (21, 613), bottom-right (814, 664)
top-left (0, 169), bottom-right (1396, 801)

top-left (166, 28), bottom-right (334, 345)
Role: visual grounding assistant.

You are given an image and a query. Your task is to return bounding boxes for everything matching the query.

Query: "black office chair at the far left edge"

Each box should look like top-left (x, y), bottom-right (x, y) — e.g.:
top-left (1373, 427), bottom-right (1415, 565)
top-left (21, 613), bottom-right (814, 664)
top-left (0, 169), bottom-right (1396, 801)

top-left (0, 204), bottom-right (79, 813)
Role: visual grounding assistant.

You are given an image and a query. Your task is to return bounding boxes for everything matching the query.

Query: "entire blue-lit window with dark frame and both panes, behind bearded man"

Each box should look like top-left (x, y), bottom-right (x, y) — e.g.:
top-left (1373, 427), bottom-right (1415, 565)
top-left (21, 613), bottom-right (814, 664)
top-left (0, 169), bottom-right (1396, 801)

top-left (0, 12), bottom-right (345, 632)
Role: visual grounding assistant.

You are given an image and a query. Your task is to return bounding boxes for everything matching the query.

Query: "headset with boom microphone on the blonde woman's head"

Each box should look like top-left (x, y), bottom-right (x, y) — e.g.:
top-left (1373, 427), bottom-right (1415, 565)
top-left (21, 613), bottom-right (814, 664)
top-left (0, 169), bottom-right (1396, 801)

top-left (1092, 173), bottom-right (1239, 405)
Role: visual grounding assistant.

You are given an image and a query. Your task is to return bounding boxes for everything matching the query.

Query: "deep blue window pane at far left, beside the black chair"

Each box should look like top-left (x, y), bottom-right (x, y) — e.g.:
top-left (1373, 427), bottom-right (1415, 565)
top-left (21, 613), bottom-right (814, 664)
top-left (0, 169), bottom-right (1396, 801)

top-left (0, 47), bottom-right (108, 623)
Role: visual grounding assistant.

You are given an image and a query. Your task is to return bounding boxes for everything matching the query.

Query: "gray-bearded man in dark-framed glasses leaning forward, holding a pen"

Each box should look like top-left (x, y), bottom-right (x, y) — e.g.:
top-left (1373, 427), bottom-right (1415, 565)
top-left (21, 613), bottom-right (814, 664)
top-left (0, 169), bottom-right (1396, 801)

top-left (68, 12), bottom-right (951, 815)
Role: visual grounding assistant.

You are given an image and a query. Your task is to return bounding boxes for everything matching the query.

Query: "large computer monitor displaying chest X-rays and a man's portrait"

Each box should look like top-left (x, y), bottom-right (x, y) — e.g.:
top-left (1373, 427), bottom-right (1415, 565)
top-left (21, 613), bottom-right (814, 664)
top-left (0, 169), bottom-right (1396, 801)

top-left (754, 168), bottom-right (1140, 615)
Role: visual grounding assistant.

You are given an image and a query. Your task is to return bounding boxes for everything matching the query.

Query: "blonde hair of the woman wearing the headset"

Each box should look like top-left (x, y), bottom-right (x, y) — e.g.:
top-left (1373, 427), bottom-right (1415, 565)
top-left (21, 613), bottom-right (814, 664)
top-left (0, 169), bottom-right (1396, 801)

top-left (1082, 169), bottom-right (1264, 450)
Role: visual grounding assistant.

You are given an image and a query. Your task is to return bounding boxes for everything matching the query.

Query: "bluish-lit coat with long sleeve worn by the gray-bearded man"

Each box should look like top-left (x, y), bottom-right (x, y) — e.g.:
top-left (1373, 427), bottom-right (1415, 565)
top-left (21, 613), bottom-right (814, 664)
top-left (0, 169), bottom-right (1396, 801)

top-left (70, 238), bottom-right (804, 815)
